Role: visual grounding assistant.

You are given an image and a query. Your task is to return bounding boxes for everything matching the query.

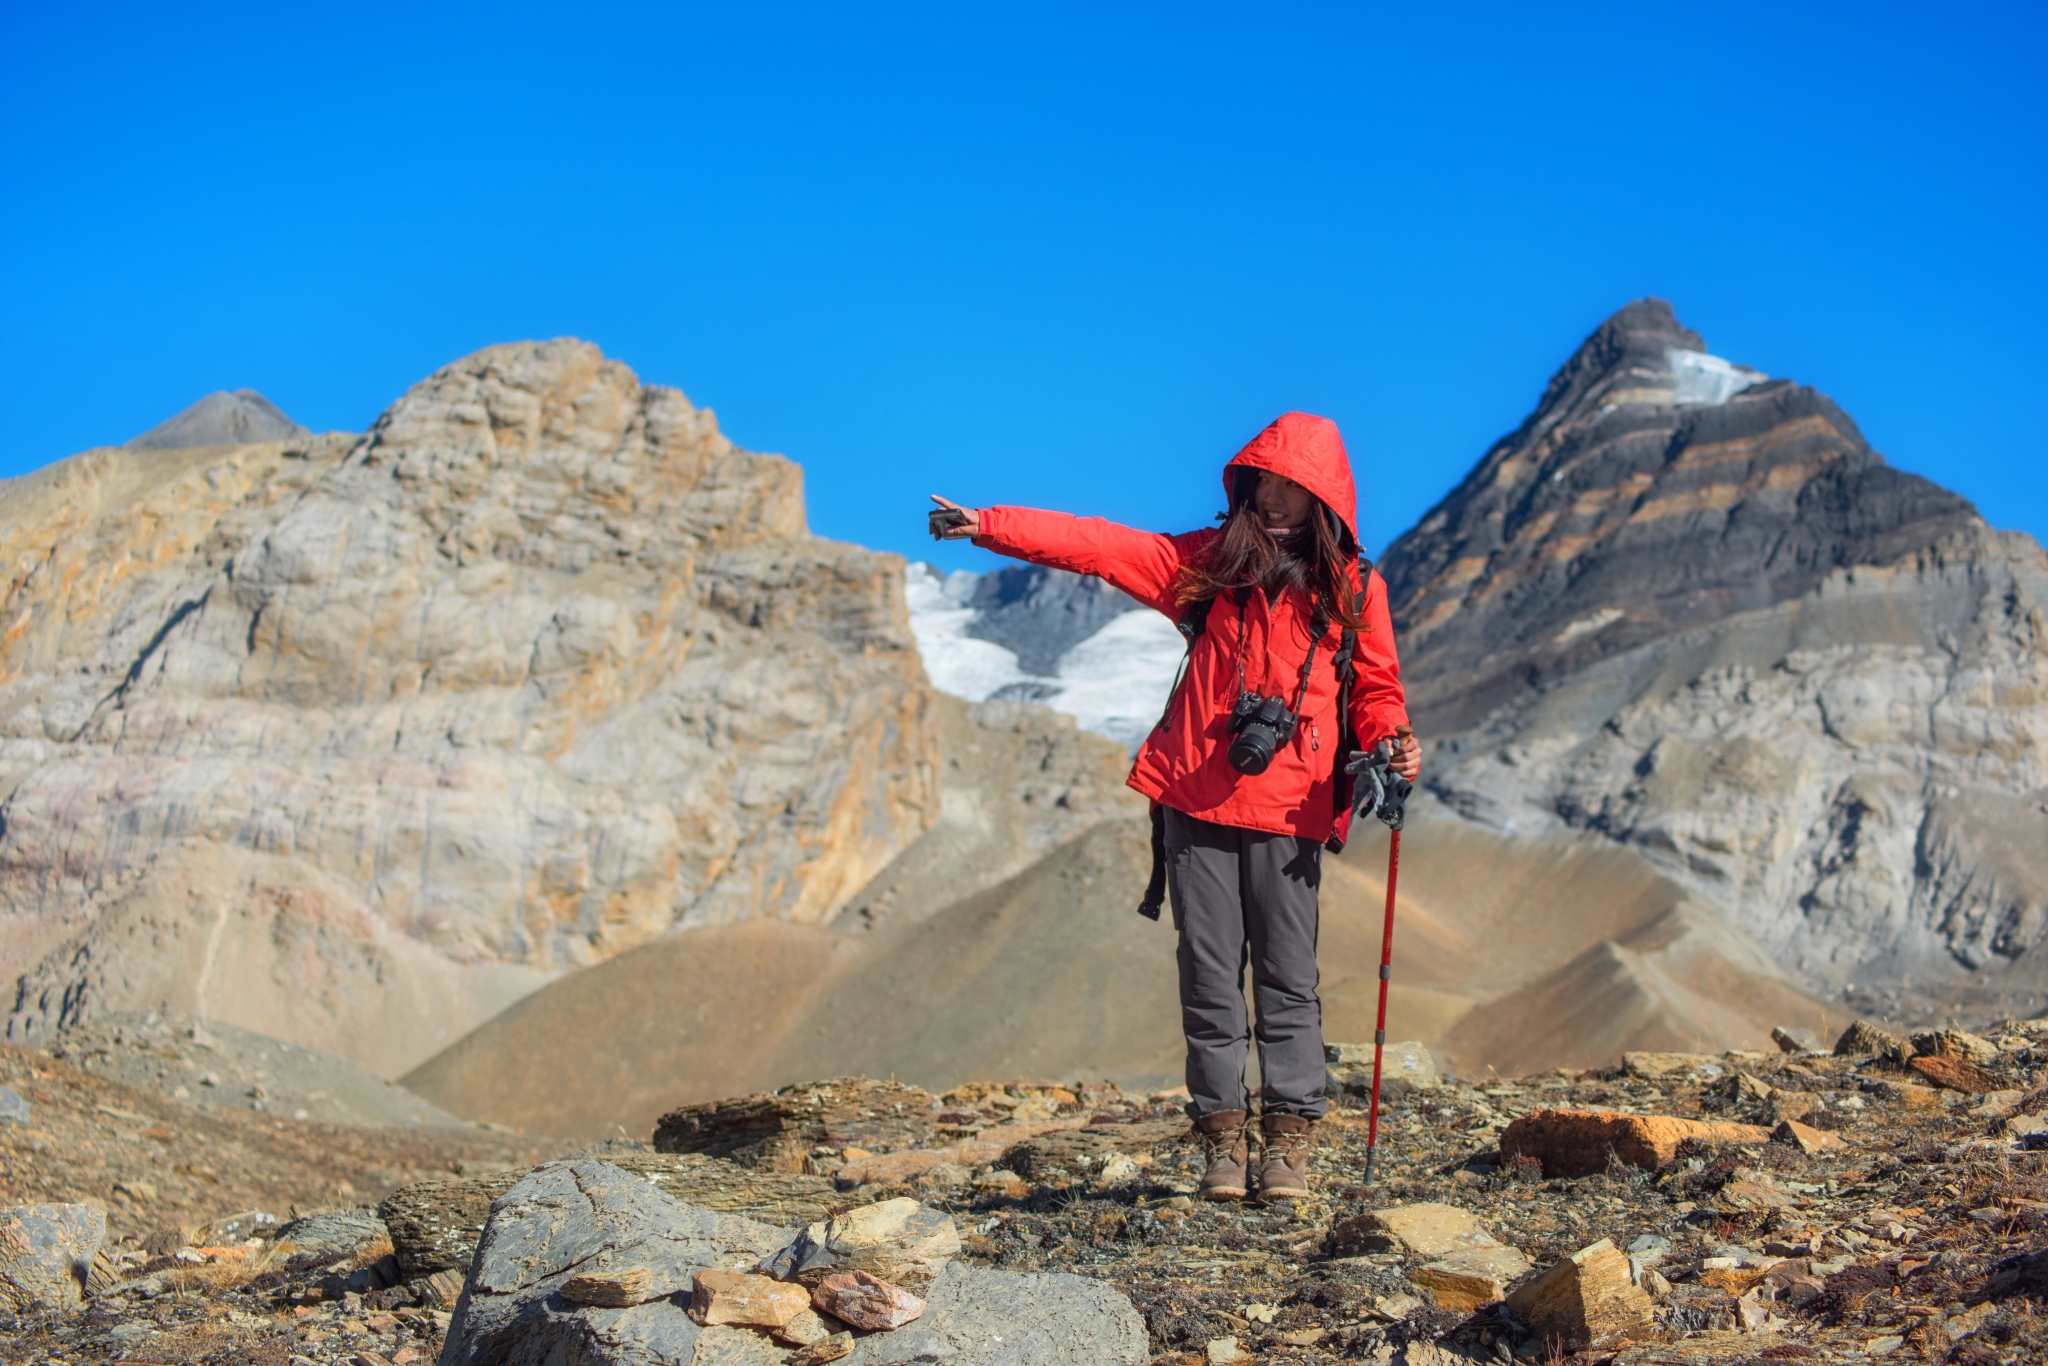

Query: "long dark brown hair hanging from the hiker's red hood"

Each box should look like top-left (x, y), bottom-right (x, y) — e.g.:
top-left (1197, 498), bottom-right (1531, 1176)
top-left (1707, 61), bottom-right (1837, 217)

top-left (1174, 467), bottom-right (1364, 631)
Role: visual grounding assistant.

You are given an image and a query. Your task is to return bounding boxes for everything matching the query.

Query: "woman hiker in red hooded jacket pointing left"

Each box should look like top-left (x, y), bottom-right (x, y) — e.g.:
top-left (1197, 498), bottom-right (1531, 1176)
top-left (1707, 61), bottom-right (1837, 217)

top-left (932, 412), bottom-right (1421, 1200)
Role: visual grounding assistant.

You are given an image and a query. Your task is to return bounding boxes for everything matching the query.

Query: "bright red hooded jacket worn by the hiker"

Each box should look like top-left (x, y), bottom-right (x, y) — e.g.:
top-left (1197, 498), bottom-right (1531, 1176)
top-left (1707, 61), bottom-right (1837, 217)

top-left (975, 412), bottom-right (1407, 840)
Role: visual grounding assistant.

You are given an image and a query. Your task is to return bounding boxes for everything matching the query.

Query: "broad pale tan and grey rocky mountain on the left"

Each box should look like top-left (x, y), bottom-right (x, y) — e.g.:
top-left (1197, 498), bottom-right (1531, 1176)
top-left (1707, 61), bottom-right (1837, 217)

top-left (0, 340), bottom-right (938, 1071)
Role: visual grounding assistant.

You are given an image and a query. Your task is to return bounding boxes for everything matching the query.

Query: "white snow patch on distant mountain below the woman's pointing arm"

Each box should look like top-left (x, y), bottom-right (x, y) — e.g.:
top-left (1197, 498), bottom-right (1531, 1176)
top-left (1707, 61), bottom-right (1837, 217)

top-left (903, 563), bottom-right (1186, 752)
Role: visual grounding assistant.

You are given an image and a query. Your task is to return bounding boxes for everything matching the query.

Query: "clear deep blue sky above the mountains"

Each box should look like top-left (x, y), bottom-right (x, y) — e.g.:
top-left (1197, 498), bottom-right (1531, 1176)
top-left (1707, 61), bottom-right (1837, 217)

top-left (0, 0), bottom-right (2048, 565)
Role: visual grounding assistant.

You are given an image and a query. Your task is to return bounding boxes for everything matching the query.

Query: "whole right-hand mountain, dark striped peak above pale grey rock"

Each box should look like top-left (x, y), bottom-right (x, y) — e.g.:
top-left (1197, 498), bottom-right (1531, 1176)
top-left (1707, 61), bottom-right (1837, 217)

top-left (1382, 299), bottom-right (2048, 1014)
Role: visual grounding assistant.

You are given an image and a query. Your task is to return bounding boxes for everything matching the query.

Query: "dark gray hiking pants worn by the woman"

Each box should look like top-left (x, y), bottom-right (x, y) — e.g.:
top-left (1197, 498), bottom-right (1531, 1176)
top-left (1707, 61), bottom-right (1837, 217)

top-left (1165, 807), bottom-right (1329, 1118)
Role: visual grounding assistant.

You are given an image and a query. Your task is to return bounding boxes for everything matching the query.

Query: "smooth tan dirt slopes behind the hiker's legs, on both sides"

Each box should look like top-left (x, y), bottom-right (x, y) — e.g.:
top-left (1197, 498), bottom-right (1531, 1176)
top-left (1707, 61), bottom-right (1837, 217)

top-left (403, 702), bottom-right (1817, 1137)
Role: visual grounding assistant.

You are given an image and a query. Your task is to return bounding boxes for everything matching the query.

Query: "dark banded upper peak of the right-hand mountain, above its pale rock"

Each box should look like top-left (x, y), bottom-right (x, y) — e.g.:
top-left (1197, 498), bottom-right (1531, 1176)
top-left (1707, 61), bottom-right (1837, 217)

top-left (1380, 299), bottom-right (1982, 731)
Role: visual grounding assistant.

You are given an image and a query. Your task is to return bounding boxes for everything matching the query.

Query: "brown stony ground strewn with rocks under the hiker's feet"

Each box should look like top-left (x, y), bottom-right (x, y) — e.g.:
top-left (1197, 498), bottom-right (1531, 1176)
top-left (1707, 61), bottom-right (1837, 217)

top-left (0, 1022), bottom-right (2048, 1366)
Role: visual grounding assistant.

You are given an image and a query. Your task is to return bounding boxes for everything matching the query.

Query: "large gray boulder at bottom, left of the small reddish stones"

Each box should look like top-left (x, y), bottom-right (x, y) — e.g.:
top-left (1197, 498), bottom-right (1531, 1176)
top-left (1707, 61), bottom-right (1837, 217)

top-left (440, 1159), bottom-right (788, 1366)
